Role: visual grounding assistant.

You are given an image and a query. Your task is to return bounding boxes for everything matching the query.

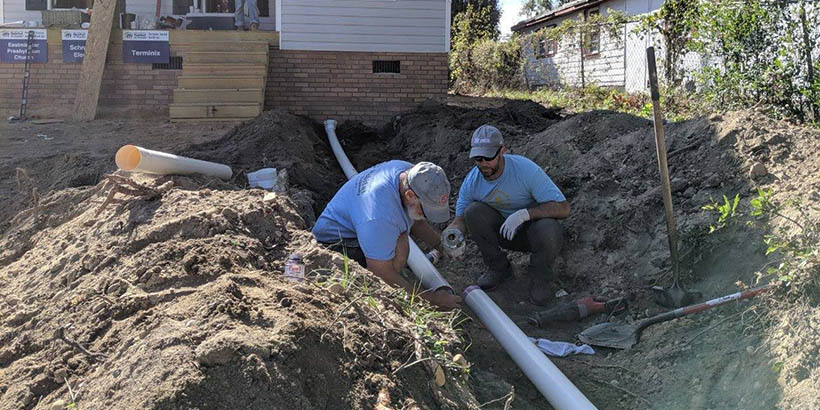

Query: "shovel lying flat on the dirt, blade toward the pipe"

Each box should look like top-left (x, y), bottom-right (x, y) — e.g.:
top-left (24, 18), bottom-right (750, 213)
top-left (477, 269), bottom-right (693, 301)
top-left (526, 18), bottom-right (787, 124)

top-left (578, 285), bottom-right (773, 349)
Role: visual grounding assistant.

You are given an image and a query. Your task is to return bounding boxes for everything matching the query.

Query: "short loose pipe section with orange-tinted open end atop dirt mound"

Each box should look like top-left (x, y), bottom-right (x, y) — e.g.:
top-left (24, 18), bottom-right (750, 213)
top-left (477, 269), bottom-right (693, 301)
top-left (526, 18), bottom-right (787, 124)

top-left (114, 145), bottom-right (233, 180)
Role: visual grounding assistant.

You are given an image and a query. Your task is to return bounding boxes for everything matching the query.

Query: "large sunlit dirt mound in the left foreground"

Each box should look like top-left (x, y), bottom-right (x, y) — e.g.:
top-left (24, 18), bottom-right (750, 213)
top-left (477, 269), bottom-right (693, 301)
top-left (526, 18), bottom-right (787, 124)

top-left (0, 174), bottom-right (476, 409)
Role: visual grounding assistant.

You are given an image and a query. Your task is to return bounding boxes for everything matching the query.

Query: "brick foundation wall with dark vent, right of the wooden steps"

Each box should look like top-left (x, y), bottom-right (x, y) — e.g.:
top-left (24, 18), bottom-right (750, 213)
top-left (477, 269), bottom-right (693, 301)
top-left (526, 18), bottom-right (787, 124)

top-left (265, 50), bottom-right (447, 126)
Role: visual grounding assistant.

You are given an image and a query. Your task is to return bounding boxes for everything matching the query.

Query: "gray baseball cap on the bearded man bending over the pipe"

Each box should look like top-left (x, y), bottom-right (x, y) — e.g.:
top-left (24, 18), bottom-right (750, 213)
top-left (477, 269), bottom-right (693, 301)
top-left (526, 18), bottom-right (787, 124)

top-left (407, 162), bottom-right (450, 223)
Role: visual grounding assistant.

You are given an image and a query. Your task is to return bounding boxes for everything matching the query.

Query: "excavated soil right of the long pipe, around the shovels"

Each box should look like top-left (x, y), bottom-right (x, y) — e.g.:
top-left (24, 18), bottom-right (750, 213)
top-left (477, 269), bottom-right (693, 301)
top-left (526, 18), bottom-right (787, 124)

top-left (348, 104), bottom-right (820, 409)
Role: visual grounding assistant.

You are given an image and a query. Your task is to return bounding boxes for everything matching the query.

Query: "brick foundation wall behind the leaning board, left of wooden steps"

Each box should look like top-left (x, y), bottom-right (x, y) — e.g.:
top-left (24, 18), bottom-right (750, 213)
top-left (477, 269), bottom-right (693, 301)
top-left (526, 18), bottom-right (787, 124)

top-left (0, 35), bottom-right (181, 119)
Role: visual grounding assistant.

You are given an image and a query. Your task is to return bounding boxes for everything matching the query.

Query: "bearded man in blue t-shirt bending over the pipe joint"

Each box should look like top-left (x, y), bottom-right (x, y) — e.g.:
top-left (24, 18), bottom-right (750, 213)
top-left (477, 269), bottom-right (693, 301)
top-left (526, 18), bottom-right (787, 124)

top-left (313, 161), bottom-right (461, 309)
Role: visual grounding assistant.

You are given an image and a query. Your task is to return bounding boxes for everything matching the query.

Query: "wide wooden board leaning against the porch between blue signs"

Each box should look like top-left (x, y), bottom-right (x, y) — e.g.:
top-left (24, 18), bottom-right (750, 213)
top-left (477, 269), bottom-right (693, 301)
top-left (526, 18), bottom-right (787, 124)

top-left (74, 0), bottom-right (117, 121)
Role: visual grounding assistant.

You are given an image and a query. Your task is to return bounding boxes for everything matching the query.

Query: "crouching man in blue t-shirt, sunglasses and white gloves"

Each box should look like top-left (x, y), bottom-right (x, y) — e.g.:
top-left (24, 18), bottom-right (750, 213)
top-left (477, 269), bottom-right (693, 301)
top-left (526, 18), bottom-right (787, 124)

top-left (445, 125), bottom-right (570, 305)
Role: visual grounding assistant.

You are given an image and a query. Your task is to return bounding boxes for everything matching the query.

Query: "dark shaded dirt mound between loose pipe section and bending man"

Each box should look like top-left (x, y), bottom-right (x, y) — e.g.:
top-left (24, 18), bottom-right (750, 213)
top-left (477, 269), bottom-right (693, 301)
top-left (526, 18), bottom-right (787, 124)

top-left (181, 109), bottom-right (345, 215)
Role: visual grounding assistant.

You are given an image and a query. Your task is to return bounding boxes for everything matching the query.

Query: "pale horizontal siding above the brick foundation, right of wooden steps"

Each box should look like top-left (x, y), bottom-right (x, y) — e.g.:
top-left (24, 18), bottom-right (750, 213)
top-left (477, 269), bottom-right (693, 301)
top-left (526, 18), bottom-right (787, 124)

top-left (280, 0), bottom-right (449, 53)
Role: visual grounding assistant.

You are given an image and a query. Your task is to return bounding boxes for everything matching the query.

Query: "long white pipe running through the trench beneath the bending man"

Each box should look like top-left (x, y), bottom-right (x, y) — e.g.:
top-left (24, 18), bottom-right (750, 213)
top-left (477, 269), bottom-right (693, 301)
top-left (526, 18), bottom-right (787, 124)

top-left (325, 120), bottom-right (596, 410)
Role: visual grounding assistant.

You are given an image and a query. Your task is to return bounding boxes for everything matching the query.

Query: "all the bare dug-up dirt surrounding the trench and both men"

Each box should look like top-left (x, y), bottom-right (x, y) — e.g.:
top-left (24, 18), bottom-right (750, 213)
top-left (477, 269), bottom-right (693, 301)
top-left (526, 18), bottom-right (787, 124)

top-left (0, 98), bottom-right (820, 409)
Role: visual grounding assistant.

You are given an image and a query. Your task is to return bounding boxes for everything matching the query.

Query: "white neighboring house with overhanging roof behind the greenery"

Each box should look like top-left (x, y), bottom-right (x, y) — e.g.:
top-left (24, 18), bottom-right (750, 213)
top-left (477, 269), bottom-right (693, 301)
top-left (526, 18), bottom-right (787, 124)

top-left (512, 0), bottom-right (663, 91)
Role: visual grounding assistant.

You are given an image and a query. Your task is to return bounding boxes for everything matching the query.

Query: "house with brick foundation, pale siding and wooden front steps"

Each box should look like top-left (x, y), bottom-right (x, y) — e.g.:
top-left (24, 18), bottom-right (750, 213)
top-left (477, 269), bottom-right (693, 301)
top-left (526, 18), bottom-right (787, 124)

top-left (0, 0), bottom-right (451, 124)
